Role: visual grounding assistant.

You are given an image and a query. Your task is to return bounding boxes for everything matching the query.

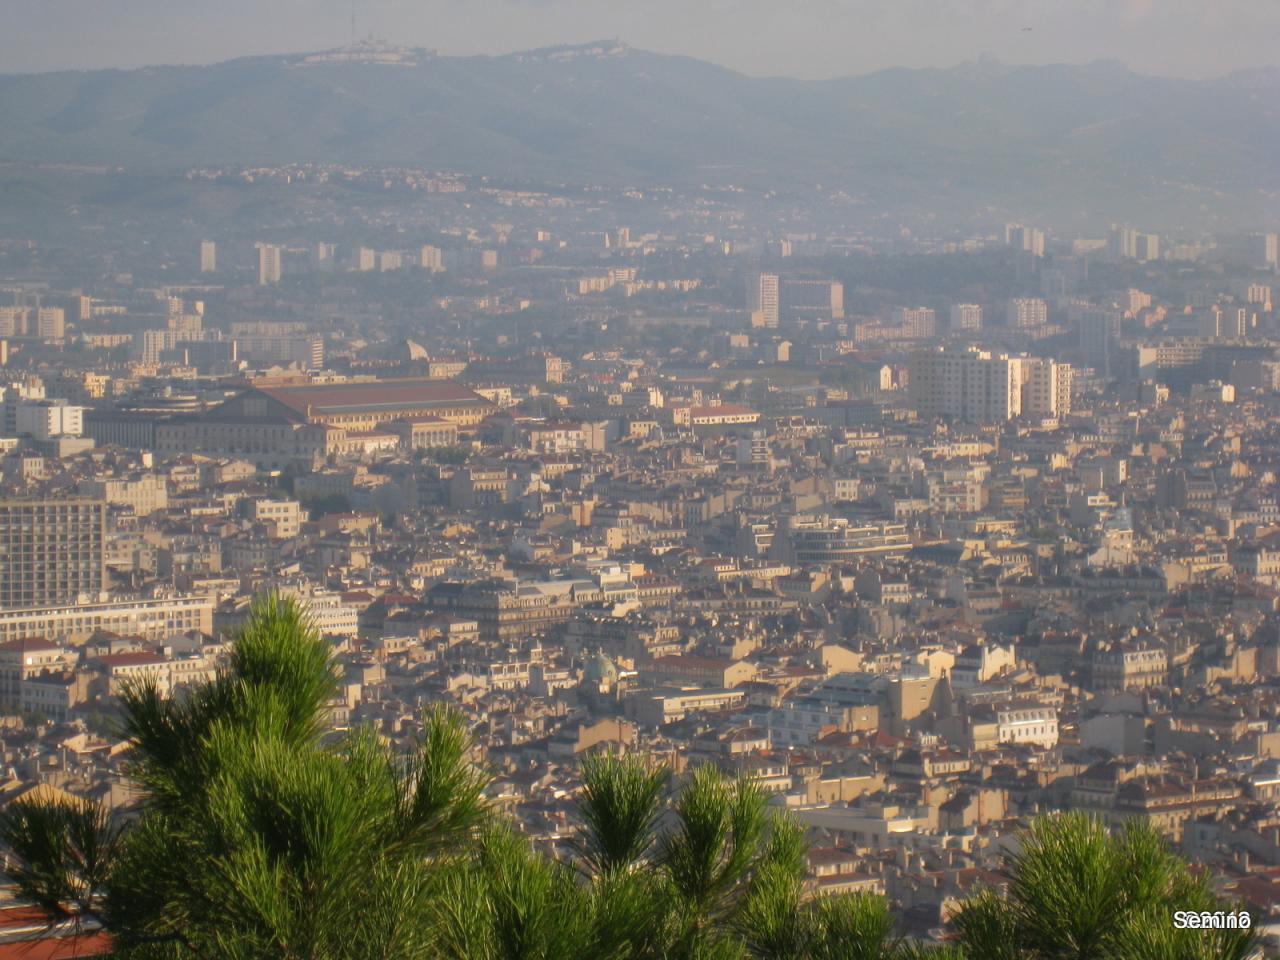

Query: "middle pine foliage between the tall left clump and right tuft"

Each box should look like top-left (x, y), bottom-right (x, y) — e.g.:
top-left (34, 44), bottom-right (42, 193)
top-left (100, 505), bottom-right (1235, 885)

top-left (442, 755), bottom-right (945, 960)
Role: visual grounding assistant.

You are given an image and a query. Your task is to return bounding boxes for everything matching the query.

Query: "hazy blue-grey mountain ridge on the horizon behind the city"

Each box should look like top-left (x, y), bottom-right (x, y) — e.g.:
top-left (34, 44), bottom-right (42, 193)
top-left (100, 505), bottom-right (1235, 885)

top-left (0, 41), bottom-right (1280, 228)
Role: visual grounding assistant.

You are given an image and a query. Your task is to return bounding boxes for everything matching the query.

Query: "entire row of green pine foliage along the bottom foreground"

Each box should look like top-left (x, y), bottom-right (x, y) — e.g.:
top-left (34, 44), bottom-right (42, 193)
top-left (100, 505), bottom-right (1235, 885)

top-left (0, 596), bottom-right (1254, 960)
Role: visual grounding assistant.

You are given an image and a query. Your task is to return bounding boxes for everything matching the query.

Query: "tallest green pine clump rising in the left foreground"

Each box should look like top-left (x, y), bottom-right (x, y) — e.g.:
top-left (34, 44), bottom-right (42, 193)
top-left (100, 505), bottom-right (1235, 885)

top-left (0, 596), bottom-right (484, 960)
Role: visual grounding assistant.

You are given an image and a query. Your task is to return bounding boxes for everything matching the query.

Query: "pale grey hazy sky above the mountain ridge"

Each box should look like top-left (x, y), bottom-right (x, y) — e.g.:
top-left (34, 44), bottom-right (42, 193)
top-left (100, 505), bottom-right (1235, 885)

top-left (0, 0), bottom-right (1280, 77)
